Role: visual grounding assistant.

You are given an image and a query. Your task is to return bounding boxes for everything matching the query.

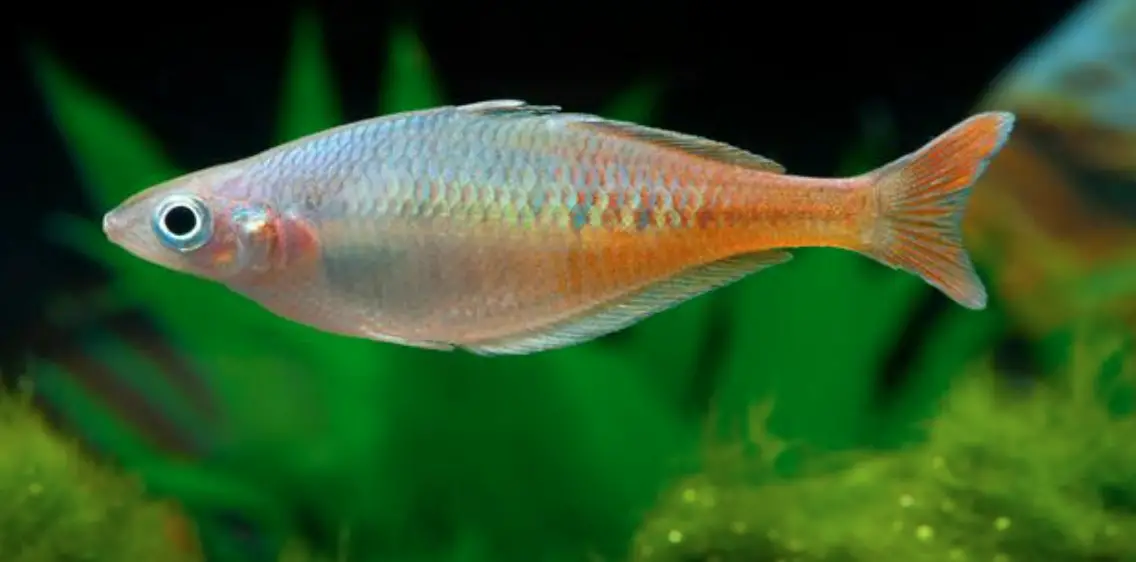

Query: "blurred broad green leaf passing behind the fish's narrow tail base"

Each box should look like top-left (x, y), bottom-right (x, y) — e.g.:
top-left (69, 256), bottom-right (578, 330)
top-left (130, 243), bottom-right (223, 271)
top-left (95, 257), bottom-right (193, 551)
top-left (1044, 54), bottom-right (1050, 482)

top-left (722, 110), bottom-right (926, 448)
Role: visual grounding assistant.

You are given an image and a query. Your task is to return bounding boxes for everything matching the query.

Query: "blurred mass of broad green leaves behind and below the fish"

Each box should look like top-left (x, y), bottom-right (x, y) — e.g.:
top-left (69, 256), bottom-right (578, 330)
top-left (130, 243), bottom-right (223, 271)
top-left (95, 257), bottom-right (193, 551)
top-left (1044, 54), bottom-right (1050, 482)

top-left (24, 7), bottom-right (1013, 561)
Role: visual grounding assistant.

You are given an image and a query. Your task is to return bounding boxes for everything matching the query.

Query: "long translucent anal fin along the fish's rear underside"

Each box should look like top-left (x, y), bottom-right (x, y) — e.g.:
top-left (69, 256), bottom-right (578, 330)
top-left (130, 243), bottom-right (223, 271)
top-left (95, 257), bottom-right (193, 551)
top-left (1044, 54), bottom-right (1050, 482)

top-left (462, 250), bottom-right (792, 355)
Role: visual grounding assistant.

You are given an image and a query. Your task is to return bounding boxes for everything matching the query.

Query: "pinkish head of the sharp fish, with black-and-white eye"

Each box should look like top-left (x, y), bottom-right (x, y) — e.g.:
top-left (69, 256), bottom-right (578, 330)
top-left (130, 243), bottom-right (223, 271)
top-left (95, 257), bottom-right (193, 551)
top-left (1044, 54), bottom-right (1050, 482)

top-left (102, 167), bottom-right (297, 283)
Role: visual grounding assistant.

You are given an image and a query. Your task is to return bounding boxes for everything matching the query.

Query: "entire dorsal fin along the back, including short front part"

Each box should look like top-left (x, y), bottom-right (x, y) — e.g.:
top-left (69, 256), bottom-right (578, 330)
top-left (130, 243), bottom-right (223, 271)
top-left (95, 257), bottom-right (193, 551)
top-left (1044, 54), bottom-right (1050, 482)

top-left (457, 100), bottom-right (785, 174)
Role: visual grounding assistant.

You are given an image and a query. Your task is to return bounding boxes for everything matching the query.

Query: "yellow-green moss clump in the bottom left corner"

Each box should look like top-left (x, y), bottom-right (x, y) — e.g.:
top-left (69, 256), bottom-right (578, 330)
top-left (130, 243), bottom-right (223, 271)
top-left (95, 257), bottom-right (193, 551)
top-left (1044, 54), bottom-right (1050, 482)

top-left (0, 386), bottom-right (200, 562)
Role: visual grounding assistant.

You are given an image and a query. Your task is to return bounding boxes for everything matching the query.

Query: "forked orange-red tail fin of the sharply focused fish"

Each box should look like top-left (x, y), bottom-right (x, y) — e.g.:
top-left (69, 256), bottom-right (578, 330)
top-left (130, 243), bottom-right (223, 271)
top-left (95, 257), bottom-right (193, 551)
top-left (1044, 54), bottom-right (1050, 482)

top-left (867, 111), bottom-right (1014, 310)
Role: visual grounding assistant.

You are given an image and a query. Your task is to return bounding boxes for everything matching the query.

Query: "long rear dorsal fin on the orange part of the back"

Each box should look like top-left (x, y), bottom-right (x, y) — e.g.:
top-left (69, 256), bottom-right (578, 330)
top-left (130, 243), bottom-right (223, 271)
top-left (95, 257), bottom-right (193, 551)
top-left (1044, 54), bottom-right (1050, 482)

top-left (578, 119), bottom-right (785, 174)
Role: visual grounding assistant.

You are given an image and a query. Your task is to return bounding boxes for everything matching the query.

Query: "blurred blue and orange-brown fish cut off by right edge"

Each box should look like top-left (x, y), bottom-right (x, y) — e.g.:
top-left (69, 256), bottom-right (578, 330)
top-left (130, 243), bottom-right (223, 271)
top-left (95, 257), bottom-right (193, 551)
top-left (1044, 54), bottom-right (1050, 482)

top-left (963, 0), bottom-right (1136, 338)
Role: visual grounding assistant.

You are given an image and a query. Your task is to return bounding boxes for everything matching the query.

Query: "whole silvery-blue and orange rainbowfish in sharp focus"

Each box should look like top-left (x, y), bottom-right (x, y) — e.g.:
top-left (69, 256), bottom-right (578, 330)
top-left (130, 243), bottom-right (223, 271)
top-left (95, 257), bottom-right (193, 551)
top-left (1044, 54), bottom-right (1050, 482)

top-left (102, 100), bottom-right (1014, 355)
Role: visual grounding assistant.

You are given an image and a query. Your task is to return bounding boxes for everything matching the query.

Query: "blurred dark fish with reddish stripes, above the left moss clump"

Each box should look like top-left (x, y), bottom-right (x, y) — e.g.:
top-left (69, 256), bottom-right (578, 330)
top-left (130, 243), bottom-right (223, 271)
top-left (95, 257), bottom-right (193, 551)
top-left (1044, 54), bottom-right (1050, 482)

top-left (19, 286), bottom-right (224, 553)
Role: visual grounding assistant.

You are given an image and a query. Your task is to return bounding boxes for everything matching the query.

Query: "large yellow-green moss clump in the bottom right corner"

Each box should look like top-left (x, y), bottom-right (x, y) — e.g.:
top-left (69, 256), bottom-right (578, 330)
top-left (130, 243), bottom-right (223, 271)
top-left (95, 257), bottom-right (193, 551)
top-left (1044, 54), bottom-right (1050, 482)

top-left (632, 326), bottom-right (1136, 562)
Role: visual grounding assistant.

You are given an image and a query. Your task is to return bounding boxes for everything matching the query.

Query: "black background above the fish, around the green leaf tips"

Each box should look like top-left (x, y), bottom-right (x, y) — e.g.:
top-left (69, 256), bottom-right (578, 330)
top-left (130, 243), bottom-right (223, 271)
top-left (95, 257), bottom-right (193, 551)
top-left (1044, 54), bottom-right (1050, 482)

top-left (0, 0), bottom-right (1077, 361)
